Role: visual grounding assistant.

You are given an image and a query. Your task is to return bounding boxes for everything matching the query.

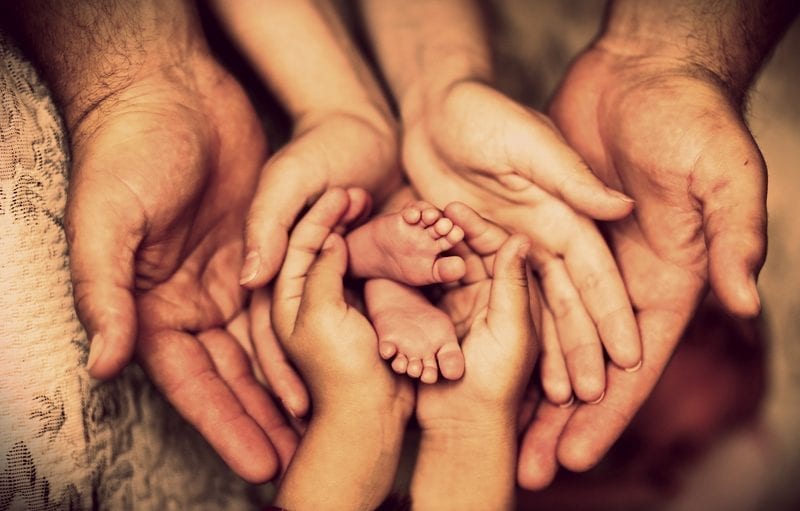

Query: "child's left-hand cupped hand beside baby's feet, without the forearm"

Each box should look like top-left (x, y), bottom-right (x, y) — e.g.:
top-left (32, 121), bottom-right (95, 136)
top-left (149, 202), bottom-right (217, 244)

top-left (272, 189), bottom-right (413, 417)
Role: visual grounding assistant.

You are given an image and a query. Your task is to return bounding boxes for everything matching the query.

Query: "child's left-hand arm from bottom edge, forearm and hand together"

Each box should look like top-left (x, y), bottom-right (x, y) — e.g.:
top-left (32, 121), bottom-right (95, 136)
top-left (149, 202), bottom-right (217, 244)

top-left (272, 189), bottom-right (414, 510)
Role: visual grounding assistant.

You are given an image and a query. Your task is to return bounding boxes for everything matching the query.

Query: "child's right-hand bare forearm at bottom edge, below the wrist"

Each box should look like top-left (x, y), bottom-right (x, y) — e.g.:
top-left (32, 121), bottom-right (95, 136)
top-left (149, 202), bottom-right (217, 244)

top-left (411, 421), bottom-right (517, 511)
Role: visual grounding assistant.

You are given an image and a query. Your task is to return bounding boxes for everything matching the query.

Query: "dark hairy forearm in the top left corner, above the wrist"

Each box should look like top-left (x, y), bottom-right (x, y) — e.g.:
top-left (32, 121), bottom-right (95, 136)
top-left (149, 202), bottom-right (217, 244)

top-left (4, 0), bottom-right (207, 126)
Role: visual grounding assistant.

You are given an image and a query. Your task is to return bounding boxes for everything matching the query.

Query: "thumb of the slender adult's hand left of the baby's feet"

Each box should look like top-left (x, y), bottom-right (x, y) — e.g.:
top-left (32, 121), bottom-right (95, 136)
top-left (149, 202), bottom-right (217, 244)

top-left (239, 151), bottom-right (324, 289)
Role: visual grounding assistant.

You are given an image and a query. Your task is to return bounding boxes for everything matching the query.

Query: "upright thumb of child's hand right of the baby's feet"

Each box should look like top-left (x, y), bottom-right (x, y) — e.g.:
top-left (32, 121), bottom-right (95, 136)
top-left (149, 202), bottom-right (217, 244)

top-left (487, 234), bottom-right (531, 331)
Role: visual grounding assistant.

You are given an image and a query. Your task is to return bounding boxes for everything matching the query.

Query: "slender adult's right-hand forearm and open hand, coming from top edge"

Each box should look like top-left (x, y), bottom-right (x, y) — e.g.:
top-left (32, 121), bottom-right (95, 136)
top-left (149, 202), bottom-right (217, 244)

top-left (362, 0), bottom-right (641, 403)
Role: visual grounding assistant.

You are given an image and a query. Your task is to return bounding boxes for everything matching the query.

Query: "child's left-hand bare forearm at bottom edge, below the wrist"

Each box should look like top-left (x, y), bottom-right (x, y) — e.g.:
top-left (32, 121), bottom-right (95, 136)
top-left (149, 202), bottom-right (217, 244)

top-left (275, 408), bottom-right (408, 510)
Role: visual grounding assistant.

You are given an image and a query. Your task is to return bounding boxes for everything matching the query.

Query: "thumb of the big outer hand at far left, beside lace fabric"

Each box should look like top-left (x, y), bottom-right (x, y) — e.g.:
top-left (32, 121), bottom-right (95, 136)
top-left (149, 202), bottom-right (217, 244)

top-left (67, 184), bottom-right (144, 379)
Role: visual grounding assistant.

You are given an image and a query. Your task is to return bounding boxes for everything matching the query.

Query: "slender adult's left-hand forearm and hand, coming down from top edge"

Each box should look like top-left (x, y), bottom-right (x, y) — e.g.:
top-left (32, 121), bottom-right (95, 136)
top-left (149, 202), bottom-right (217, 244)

top-left (211, 0), bottom-right (401, 424)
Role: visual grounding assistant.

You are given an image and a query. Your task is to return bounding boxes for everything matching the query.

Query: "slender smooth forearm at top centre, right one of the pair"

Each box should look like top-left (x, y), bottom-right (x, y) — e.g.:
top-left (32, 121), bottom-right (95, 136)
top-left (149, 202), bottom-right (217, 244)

top-left (361, 0), bottom-right (492, 115)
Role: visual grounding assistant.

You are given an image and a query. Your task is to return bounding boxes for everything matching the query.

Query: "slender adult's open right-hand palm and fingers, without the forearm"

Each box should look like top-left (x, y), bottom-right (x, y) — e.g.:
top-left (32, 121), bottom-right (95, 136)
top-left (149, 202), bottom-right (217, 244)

top-left (403, 81), bottom-right (640, 402)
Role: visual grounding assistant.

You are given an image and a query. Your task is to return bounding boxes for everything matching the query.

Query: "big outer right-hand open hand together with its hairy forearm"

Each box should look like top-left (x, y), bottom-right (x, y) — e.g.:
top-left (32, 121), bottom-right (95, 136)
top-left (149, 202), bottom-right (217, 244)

top-left (519, 0), bottom-right (798, 488)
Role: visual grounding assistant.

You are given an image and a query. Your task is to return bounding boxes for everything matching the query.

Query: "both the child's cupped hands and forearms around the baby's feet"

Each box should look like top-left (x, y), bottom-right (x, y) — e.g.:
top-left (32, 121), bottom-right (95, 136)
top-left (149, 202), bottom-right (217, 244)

top-left (273, 189), bottom-right (538, 510)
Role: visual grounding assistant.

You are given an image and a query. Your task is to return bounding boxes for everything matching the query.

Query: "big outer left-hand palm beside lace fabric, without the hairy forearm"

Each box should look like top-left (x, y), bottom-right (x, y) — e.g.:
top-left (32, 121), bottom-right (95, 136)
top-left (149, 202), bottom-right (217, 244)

top-left (67, 56), bottom-right (297, 482)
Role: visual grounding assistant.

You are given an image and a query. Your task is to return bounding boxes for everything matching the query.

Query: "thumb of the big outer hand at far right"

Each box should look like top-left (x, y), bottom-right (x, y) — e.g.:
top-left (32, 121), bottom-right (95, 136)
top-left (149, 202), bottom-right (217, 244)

top-left (696, 125), bottom-right (767, 317)
